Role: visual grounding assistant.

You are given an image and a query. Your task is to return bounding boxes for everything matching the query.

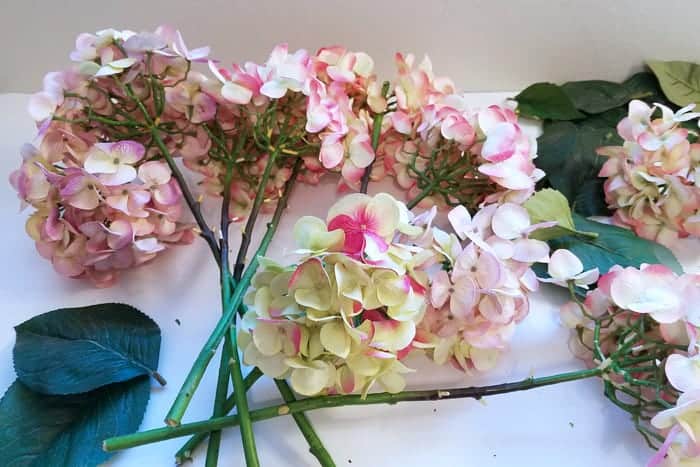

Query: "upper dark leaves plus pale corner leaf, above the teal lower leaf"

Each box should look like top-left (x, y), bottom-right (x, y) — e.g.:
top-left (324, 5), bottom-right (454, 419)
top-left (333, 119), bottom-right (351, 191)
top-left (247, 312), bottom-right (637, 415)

top-left (515, 61), bottom-right (700, 216)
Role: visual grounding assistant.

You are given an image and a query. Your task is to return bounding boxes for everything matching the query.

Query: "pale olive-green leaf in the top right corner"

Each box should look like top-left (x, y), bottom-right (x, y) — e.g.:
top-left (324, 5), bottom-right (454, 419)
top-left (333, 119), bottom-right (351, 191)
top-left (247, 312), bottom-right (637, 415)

top-left (647, 60), bottom-right (700, 107)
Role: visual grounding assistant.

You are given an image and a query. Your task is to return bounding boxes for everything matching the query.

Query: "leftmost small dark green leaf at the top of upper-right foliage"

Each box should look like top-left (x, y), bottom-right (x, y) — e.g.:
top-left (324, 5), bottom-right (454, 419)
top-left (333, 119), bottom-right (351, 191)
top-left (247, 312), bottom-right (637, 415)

top-left (515, 83), bottom-right (585, 120)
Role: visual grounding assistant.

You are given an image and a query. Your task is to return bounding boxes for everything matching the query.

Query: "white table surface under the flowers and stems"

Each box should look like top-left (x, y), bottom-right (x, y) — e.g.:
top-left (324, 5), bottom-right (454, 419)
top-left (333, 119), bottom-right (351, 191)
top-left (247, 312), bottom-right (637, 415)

top-left (0, 93), bottom-right (700, 467)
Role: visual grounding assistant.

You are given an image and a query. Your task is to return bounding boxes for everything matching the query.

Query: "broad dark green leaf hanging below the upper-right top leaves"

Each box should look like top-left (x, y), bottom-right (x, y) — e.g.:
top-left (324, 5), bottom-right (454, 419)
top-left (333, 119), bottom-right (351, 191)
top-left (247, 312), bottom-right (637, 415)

top-left (535, 122), bottom-right (617, 204)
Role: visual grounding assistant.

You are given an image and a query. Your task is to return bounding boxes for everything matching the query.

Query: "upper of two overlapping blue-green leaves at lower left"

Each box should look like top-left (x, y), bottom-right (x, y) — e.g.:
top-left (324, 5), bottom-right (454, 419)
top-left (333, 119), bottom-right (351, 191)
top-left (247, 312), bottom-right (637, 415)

top-left (14, 303), bottom-right (162, 394)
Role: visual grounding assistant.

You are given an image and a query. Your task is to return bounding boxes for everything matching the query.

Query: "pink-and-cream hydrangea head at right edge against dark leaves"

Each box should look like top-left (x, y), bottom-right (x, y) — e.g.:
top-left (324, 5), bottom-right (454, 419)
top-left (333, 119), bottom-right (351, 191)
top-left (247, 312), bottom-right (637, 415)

top-left (598, 100), bottom-right (700, 245)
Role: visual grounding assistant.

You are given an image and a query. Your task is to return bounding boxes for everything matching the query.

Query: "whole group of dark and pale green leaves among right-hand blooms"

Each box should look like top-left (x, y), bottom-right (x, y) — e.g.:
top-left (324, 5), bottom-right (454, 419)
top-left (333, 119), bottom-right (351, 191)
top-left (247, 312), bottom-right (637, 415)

top-left (515, 61), bottom-right (700, 273)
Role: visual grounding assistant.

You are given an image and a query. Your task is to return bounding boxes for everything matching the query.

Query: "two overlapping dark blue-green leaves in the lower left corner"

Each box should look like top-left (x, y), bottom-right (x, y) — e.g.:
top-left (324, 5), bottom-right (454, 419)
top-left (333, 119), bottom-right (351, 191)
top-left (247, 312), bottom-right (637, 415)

top-left (0, 303), bottom-right (164, 467)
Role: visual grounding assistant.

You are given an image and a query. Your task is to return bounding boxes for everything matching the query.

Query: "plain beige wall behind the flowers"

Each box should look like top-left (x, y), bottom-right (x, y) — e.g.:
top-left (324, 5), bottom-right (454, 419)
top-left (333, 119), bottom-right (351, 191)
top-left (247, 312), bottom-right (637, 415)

top-left (0, 0), bottom-right (700, 92)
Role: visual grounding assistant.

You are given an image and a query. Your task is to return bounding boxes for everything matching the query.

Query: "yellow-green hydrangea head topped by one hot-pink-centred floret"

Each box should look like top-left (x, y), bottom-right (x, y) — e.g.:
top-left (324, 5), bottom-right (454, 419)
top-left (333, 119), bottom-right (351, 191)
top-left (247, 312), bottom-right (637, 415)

top-left (239, 194), bottom-right (427, 395)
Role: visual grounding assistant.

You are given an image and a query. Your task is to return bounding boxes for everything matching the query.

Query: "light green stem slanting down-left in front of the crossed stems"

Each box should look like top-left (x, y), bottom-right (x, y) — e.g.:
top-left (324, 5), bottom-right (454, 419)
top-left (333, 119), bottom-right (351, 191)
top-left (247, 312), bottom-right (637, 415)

top-left (165, 159), bottom-right (301, 426)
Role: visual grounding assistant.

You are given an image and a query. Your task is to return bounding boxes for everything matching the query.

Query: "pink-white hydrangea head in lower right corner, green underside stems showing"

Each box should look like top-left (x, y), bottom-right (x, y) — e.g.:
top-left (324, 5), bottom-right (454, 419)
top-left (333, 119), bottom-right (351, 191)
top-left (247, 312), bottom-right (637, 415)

top-left (562, 265), bottom-right (700, 466)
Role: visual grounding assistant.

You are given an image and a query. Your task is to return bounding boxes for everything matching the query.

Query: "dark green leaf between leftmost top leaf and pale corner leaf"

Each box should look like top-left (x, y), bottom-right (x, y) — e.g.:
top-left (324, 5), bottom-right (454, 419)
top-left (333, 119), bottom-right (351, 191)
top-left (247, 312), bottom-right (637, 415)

top-left (561, 80), bottom-right (630, 114)
